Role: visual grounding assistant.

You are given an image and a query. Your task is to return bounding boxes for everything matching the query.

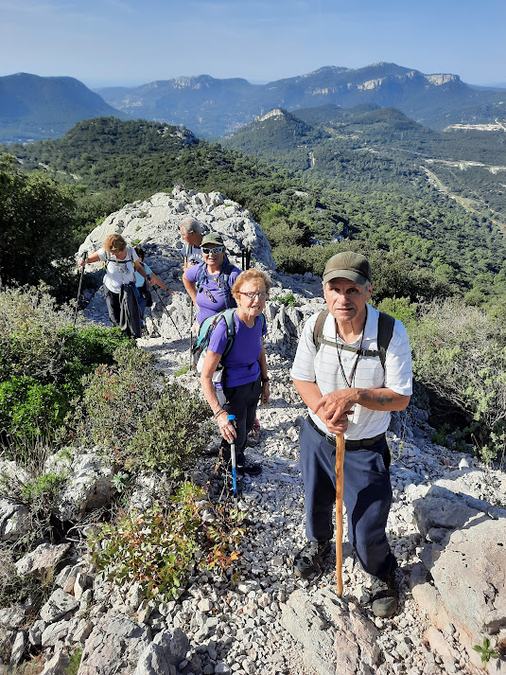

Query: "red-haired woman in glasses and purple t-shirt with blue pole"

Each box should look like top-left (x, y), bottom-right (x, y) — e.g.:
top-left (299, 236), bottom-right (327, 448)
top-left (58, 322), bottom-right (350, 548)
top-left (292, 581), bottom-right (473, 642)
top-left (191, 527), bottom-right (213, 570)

top-left (200, 269), bottom-right (271, 476)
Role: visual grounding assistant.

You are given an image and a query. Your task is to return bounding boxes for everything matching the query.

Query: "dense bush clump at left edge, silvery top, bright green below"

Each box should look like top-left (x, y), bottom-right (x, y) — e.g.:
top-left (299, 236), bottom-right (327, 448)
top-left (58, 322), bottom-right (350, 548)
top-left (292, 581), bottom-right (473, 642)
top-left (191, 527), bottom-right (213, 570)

top-left (0, 287), bottom-right (130, 458)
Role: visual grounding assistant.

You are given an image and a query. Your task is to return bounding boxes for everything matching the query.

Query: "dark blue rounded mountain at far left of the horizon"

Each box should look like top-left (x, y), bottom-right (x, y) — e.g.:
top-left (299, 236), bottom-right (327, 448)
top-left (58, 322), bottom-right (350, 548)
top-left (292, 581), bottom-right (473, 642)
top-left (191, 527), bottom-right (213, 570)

top-left (0, 73), bottom-right (125, 142)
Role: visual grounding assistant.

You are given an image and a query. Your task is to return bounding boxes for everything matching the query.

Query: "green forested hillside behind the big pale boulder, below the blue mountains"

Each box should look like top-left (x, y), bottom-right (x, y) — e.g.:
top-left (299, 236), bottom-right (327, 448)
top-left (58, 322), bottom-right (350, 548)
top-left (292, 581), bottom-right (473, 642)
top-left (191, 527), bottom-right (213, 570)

top-left (3, 115), bottom-right (506, 313)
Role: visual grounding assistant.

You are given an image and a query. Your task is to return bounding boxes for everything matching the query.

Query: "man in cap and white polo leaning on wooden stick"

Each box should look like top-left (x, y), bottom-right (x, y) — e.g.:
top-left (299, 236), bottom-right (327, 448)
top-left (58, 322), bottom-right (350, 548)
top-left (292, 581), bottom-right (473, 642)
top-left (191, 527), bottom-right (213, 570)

top-left (291, 251), bottom-right (412, 617)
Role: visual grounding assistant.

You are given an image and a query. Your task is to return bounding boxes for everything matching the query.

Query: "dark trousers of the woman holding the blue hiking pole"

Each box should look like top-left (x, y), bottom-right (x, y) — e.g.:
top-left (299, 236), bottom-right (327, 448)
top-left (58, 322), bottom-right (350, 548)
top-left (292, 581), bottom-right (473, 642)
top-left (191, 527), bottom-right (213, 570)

top-left (221, 377), bottom-right (262, 465)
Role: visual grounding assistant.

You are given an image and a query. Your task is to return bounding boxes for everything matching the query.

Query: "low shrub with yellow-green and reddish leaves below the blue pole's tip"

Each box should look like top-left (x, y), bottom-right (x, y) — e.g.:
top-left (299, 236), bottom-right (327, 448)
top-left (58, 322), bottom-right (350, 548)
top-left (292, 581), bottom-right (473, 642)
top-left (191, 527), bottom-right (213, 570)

top-left (88, 483), bottom-right (244, 599)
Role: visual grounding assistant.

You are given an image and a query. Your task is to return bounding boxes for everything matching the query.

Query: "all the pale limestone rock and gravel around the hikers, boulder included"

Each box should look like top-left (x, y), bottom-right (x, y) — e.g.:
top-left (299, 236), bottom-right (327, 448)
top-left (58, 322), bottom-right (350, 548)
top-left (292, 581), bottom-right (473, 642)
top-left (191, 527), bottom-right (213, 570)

top-left (0, 187), bottom-right (506, 675)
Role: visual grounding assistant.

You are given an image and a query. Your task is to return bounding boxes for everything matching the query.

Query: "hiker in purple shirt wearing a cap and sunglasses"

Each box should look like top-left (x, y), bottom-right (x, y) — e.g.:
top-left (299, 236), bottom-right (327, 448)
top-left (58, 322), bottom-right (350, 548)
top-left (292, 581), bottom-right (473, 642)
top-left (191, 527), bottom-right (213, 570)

top-left (183, 232), bottom-right (241, 325)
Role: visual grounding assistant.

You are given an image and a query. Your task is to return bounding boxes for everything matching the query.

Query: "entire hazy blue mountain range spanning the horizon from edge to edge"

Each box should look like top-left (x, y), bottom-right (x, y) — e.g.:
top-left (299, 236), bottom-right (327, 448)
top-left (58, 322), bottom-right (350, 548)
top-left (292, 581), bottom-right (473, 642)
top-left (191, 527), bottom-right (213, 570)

top-left (0, 63), bottom-right (506, 141)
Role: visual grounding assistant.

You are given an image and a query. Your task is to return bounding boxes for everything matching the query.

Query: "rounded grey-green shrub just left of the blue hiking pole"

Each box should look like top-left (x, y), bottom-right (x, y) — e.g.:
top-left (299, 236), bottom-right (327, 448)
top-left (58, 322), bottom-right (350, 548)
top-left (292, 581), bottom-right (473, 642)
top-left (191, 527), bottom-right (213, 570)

top-left (126, 383), bottom-right (210, 478)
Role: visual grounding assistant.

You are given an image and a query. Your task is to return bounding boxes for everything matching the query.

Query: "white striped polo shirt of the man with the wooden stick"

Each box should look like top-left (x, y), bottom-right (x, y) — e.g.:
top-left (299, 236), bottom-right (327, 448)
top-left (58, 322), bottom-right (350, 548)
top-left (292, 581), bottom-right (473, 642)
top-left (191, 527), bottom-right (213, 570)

top-left (290, 305), bottom-right (413, 440)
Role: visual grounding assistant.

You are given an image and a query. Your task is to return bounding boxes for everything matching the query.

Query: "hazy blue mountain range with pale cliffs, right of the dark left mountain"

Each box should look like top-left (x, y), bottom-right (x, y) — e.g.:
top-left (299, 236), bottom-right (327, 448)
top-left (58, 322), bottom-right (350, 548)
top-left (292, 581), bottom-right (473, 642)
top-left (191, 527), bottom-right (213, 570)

top-left (99, 63), bottom-right (506, 137)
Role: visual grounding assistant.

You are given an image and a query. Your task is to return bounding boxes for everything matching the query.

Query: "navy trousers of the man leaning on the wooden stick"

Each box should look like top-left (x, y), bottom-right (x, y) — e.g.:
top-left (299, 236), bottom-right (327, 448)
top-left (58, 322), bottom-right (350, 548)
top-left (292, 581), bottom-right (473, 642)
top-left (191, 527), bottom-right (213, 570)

top-left (300, 420), bottom-right (396, 580)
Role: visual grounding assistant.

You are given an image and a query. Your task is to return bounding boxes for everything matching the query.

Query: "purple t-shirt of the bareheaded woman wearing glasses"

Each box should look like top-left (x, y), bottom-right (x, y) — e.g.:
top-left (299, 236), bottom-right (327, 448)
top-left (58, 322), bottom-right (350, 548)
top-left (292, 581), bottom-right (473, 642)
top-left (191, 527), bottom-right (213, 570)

top-left (208, 312), bottom-right (267, 387)
